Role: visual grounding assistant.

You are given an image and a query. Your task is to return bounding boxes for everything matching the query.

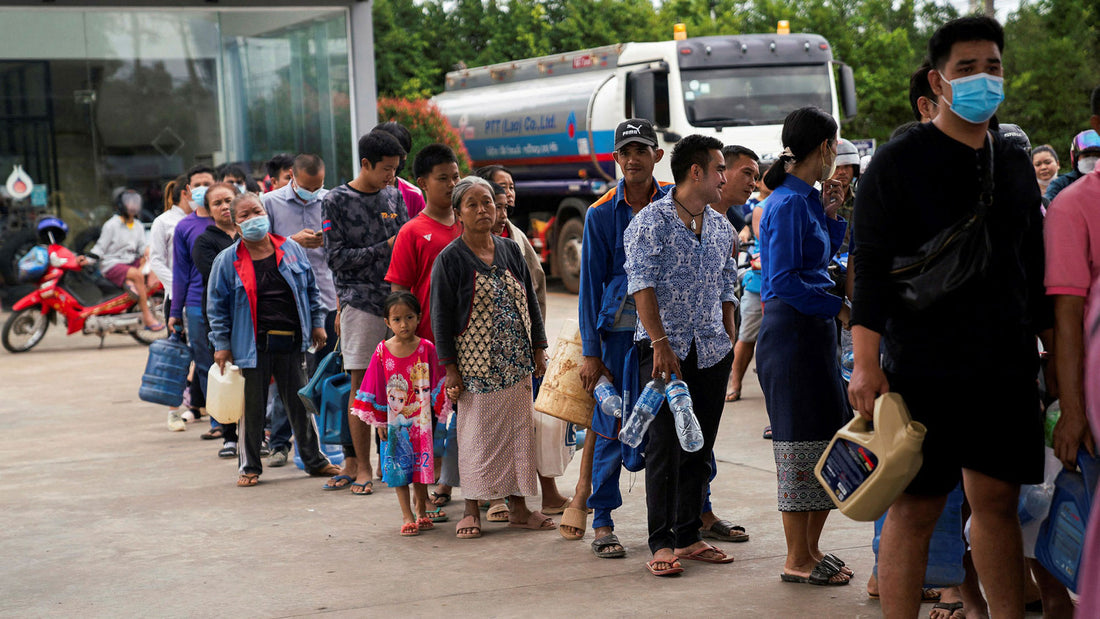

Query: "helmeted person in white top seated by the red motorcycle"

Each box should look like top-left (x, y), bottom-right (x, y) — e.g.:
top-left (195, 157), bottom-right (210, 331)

top-left (80, 189), bottom-right (164, 331)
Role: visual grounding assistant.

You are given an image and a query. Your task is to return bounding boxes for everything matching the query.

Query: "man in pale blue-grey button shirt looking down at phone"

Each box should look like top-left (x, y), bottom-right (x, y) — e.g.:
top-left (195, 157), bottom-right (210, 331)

top-left (261, 154), bottom-right (337, 466)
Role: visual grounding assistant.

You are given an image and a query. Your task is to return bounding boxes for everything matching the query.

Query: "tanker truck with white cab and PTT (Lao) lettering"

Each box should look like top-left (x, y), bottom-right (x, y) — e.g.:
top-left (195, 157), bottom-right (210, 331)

top-left (435, 27), bottom-right (856, 292)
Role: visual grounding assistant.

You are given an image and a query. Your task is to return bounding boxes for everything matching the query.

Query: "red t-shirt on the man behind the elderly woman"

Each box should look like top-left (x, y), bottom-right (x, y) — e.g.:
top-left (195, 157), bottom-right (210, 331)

top-left (386, 212), bottom-right (462, 343)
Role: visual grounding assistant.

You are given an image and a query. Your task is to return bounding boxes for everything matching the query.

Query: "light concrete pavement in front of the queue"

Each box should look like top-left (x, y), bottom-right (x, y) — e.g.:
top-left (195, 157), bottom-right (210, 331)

top-left (0, 292), bottom-right (928, 617)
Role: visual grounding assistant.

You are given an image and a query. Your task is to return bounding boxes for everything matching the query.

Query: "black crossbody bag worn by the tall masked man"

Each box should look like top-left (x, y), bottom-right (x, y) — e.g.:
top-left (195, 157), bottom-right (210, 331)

top-left (890, 134), bottom-right (993, 311)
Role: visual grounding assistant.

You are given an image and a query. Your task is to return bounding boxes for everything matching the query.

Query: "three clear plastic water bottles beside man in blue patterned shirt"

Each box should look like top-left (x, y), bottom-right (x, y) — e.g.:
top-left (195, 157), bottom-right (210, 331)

top-left (593, 374), bottom-right (703, 452)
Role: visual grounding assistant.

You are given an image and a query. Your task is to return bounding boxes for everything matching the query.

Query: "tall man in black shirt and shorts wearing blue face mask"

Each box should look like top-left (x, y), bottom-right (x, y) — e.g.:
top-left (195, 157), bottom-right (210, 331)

top-left (848, 16), bottom-right (1053, 617)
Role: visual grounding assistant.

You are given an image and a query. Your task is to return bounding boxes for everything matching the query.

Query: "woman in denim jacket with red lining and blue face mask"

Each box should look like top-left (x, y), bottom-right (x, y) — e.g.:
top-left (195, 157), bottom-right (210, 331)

top-left (207, 194), bottom-right (340, 487)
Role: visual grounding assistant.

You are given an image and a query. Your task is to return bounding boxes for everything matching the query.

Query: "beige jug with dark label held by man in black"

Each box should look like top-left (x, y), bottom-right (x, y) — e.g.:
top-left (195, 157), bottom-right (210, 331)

top-left (814, 394), bottom-right (927, 522)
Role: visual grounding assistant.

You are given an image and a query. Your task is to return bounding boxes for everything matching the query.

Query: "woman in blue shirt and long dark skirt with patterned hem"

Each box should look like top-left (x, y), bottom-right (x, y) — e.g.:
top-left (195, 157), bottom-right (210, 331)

top-left (757, 108), bottom-right (851, 585)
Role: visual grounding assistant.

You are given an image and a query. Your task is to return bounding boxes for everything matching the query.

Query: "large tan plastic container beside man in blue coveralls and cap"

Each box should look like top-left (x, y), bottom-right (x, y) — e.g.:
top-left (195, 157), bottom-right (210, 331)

top-left (535, 320), bottom-right (596, 428)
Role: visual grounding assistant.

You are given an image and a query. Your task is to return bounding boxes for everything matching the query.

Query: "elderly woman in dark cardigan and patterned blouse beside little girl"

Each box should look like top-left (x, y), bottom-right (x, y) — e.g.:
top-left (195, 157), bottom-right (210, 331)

top-left (431, 177), bottom-right (556, 539)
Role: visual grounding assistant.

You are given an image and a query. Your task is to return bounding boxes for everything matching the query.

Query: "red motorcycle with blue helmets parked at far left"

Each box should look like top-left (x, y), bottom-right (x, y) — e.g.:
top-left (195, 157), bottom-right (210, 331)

top-left (2, 218), bottom-right (167, 353)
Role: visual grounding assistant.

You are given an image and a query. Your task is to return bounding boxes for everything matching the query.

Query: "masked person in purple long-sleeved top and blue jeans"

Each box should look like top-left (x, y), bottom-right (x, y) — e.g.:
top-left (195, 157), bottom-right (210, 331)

top-left (168, 165), bottom-right (223, 444)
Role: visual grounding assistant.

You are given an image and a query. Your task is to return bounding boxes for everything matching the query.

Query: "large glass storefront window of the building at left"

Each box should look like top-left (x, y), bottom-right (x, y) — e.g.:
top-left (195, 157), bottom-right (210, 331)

top-left (0, 8), bottom-right (355, 239)
